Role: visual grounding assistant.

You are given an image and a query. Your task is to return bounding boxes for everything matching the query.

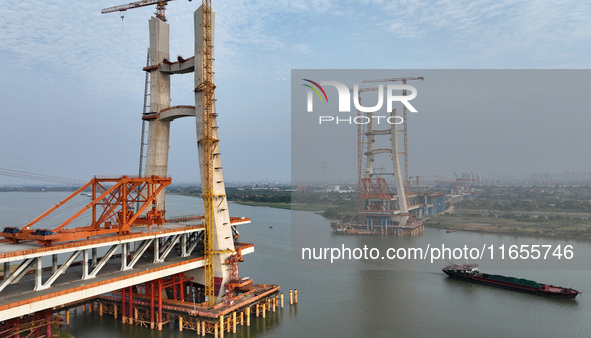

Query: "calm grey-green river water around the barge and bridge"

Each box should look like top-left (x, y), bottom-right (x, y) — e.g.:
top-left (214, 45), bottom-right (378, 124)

top-left (0, 192), bottom-right (591, 338)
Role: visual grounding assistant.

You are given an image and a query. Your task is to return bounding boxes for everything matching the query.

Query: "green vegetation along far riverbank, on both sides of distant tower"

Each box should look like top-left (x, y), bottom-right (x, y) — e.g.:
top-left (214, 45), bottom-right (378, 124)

top-left (23, 184), bottom-right (591, 239)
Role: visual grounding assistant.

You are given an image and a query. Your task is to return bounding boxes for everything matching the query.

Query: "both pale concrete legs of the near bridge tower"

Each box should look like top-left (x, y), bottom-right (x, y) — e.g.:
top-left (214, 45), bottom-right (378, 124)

top-left (143, 6), bottom-right (235, 303)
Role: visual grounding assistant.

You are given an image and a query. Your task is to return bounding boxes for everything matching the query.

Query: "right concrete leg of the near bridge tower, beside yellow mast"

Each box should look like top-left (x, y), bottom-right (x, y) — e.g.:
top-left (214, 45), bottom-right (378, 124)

top-left (187, 6), bottom-right (234, 303)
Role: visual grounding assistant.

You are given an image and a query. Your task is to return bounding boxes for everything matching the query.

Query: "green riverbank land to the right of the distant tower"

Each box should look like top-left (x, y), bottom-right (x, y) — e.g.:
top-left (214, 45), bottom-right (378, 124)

top-left (425, 186), bottom-right (591, 239)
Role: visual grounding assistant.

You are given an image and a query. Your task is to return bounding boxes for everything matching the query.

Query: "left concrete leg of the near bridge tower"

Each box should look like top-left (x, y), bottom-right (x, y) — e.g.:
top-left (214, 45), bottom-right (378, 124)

top-left (144, 17), bottom-right (170, 210)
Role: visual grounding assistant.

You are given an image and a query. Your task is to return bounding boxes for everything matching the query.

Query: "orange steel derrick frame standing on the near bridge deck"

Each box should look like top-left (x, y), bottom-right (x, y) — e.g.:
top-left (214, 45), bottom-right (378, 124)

top-left (0, 176), bottom-right (171, 246)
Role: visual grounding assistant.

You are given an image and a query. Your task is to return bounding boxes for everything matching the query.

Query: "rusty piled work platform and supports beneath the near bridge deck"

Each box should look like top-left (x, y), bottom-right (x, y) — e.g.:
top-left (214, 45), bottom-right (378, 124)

top-left (0, 282), bottom-right (298, 338)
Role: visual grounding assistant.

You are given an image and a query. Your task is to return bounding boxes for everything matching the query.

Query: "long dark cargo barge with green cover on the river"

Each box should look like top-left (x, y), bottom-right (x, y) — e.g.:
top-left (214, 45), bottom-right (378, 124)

top-left (442, 263), bottom-right (581, 299)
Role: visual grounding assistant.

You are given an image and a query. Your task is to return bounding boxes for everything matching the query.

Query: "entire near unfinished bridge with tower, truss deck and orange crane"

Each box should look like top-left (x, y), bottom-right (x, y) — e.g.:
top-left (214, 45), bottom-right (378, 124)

top-left (0, 0), bottom-right (286, 337)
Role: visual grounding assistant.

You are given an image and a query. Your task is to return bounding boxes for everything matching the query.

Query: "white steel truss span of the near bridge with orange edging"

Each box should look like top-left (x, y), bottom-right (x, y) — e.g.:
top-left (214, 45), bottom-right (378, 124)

top-left (0, 217), bottom-right (254, 320)
